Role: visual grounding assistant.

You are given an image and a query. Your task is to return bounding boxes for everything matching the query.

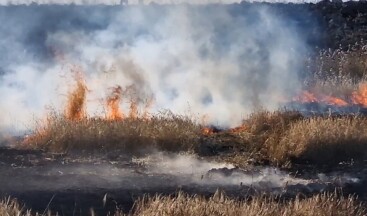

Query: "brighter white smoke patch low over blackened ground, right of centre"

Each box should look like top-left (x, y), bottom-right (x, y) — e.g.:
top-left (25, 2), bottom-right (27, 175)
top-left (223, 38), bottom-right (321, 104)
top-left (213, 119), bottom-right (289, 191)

top-left (133, 152), bottom-right (360, 190)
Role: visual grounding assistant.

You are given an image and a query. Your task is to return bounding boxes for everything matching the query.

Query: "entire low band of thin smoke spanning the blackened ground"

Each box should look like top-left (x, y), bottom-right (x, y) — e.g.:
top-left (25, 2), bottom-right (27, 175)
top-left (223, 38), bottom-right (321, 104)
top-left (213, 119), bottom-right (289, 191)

top-left (2, 153), bottom-right (360, 194)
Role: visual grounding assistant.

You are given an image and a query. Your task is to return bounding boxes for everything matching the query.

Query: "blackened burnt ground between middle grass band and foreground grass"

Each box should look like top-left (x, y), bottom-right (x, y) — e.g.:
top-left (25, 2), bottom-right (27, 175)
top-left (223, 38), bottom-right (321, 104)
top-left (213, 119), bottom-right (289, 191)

top-left (0, 148), bottom-right (367, 215)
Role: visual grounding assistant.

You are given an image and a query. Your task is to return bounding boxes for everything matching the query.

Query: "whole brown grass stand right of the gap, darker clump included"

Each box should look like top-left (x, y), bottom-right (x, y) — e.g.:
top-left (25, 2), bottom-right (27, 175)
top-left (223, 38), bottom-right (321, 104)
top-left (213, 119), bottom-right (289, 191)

top-left (218, 111), bottom-right (367, 166)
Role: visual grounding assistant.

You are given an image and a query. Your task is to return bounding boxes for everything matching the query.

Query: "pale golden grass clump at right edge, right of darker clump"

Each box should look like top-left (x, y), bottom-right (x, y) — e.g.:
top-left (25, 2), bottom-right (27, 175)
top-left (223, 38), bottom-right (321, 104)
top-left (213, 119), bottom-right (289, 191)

top-left (270, 117), bottom-right (367, 165)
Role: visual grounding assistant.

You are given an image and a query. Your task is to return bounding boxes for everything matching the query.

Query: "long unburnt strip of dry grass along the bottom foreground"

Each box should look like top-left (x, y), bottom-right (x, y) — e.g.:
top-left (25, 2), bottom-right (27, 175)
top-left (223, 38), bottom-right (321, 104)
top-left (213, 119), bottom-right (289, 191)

top-left (122, 192), bottom-right (367, 216)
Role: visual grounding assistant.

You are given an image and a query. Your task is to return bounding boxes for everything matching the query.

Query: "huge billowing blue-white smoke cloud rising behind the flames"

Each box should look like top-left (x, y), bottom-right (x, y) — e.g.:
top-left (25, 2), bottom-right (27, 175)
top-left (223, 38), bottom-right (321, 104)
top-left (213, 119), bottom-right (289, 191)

top-left (0, 2), bottom-right (307, 130)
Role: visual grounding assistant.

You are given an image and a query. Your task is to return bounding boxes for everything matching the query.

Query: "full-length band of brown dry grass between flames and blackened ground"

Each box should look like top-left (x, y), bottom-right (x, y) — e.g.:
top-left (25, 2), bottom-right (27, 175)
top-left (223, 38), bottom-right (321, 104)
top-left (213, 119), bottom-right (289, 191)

top-left (22, 111), bottom-right (367, 166)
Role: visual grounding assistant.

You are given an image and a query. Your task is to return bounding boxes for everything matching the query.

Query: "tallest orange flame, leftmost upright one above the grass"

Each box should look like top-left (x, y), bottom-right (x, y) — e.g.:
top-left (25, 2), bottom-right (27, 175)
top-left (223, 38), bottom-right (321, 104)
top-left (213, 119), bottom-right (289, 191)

top-left (65, 67), bottom-right (87, 121)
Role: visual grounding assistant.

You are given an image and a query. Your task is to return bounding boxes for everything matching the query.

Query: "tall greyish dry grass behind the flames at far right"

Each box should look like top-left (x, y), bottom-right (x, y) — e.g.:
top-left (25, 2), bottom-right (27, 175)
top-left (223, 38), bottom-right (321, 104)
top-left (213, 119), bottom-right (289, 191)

top-left (303, 41), bottom-right (367, 99)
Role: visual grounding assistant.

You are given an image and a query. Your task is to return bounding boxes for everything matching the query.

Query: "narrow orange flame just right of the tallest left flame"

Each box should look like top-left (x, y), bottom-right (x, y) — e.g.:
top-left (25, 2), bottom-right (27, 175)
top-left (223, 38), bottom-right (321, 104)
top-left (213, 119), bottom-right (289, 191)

top-left (107, 85), bottom-right (124, 120)
